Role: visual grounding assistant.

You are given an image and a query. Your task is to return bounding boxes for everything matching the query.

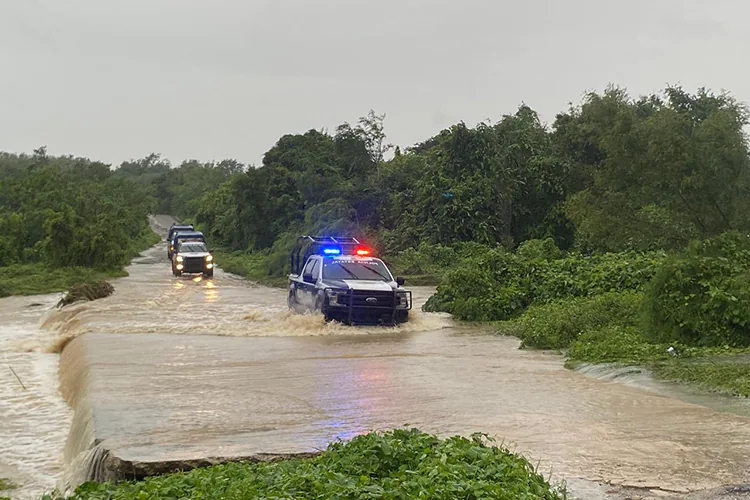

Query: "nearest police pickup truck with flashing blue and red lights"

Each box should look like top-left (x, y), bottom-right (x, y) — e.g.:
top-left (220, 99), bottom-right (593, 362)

top-left (288, 236), bottom-right (412, 325)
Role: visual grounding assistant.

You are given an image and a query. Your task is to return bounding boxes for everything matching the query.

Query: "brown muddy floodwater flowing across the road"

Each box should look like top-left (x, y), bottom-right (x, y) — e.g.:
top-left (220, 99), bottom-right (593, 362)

top-left (0, 217), bottom-right (750, 498)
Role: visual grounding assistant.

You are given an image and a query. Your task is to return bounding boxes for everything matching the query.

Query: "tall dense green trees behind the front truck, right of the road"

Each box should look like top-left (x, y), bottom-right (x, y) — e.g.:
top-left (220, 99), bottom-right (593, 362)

top-left (116, 87), bottom-right (750, 282)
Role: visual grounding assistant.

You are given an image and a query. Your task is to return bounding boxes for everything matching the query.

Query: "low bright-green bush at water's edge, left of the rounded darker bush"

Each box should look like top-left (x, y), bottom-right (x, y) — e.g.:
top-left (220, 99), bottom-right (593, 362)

top-left (515, 291), bottom-right (642, 349)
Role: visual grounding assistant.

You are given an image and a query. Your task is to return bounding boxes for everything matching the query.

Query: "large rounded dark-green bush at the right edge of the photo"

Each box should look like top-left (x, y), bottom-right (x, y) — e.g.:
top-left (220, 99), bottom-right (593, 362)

top-left (644, 233), bottom-right (750, 346)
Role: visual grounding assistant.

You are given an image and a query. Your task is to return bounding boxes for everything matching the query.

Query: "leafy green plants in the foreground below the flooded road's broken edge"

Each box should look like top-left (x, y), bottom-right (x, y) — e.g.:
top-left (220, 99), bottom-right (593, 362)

top-left (48, 429), bottom-right (566, 500)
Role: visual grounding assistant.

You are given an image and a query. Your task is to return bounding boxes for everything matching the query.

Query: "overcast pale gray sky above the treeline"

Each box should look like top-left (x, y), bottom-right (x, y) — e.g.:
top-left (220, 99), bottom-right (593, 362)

top-left (0, 0), bottom-right (750, 168)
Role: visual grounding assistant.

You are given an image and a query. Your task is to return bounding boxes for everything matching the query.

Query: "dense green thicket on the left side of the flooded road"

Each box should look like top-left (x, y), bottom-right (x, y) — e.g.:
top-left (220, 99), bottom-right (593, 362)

top-left (0, 148), bottom-right (162, 296)
